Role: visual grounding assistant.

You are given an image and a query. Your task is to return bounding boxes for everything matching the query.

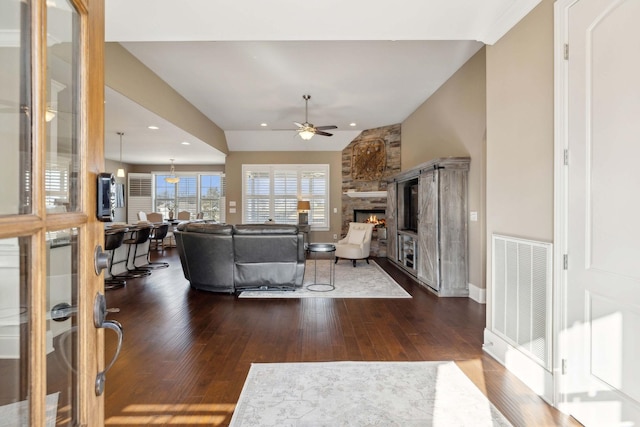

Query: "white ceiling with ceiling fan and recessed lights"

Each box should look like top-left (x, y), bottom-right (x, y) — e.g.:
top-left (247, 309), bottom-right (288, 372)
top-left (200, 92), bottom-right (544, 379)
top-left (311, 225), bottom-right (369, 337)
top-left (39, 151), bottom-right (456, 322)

top-left (105, 0), bottom-right (540, 164)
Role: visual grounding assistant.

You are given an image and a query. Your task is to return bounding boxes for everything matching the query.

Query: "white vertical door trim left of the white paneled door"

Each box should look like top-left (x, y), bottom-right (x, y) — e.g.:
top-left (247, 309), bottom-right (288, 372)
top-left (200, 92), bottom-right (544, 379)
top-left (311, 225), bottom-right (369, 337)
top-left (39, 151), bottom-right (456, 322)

top-left (552, 0), bottom-right (578, 412)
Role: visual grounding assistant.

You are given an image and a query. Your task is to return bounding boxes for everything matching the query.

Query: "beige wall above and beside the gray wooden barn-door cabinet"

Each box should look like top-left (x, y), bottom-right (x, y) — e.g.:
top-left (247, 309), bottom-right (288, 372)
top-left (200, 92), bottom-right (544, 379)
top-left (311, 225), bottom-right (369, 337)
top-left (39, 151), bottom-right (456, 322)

top-left (401, 48), bottom-right (486, 288)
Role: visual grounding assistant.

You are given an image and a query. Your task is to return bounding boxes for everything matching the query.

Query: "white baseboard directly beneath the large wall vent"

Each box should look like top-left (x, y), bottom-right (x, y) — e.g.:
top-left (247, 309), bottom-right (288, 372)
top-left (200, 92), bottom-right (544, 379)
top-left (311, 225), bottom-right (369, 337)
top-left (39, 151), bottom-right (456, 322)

top-left (482, 329), bottom-right (553, 405)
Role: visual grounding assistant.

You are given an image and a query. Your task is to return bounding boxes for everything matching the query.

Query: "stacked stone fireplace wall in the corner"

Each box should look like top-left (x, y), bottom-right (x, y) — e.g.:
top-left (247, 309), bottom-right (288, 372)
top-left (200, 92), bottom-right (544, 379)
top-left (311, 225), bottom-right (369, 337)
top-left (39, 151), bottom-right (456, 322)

top-left (341, 124), bottom-right (401, 256)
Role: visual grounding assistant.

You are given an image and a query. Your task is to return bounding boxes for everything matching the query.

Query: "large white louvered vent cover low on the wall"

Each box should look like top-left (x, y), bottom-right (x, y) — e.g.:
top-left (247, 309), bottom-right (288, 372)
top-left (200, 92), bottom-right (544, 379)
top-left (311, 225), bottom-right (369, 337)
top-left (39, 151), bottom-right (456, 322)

top-left (491, 234), bottom-right (552, 370)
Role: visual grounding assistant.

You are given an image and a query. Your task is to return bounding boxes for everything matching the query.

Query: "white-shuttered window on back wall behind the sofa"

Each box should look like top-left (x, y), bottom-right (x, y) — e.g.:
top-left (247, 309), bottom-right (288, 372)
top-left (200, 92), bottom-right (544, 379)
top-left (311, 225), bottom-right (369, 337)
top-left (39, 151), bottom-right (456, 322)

top-left (242, 165), bottom-right (329, 230)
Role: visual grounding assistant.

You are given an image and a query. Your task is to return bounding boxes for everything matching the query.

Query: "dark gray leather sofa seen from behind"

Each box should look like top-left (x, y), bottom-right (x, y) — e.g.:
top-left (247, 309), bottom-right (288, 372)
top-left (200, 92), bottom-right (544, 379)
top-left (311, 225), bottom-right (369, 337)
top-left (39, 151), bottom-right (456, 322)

top-left (174, 222), bottom-right (305, 293)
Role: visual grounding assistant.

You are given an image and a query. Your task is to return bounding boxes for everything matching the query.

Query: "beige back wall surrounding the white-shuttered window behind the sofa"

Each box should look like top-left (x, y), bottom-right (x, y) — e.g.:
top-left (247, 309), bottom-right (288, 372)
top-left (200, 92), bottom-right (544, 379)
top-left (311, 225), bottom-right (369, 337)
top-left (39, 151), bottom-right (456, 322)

top-left (226, 151), bottom-right (342, 242)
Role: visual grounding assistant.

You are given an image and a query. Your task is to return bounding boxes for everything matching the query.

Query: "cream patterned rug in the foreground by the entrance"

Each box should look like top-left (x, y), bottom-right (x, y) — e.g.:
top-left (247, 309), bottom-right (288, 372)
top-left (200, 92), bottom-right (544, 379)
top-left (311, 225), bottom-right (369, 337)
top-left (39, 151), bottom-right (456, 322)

top-left (230, 362), bottom-right (511, 427)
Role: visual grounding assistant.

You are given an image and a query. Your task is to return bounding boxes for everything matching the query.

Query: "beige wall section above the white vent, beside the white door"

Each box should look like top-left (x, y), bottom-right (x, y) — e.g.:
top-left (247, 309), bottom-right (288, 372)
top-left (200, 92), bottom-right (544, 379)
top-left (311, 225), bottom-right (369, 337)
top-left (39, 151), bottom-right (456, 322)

top-left (486, 0), bottom-right (554, 318)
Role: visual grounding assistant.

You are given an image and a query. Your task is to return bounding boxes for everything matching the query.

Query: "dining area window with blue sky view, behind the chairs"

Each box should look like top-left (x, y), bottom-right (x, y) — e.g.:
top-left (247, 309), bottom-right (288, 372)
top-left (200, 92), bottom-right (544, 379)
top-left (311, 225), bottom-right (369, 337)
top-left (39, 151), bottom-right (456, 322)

top-left (153, 173), bottom-right (225, 222)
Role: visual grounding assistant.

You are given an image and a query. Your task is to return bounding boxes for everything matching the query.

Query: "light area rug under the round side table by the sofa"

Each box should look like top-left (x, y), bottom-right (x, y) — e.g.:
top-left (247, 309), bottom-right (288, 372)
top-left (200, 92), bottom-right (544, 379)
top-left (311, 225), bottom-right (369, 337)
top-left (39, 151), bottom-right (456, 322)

top-left (239, 259), bottom-right (411, 298)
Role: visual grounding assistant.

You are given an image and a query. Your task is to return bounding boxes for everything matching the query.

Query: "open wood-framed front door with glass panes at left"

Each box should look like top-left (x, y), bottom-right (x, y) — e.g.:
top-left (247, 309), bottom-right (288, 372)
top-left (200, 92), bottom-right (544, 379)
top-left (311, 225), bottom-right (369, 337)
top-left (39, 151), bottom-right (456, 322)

top-left (0, 0), bottom-right (104, 427)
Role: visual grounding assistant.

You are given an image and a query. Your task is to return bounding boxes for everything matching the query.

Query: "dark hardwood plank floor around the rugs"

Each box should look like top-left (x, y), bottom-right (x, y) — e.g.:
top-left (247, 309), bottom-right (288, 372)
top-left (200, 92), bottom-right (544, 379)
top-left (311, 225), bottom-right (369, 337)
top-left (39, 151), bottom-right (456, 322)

top-left (105, 249), bottom-right (579, 426)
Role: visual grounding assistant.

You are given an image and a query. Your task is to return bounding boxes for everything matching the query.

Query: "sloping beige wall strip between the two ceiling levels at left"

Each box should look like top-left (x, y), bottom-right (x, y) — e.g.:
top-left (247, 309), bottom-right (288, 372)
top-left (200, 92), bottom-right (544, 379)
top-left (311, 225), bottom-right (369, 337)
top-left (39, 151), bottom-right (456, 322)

top-left (105, 43), bottom-right (229, 154)
